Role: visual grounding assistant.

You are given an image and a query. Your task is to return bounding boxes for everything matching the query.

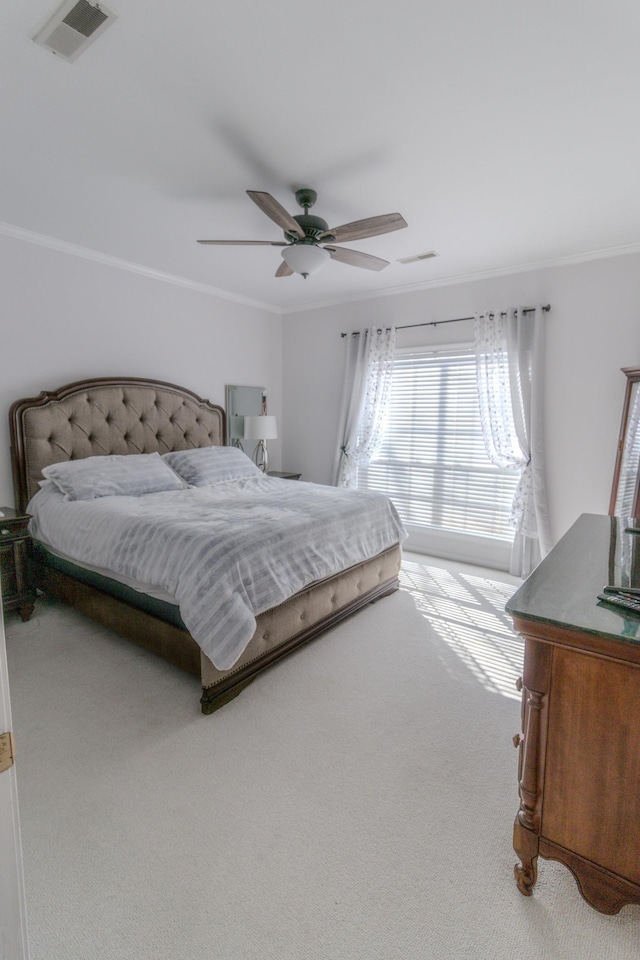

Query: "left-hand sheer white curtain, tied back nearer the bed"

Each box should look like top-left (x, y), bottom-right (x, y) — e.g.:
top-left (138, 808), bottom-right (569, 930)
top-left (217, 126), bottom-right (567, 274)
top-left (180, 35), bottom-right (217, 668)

top-left (334, 327), bottom-right (396, 487)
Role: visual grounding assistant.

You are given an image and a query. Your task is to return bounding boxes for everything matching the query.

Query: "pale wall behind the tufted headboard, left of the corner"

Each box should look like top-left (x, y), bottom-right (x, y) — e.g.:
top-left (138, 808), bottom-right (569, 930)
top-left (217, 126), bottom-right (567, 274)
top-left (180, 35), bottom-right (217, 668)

top-left (0, 236), bottom-right (282, 506)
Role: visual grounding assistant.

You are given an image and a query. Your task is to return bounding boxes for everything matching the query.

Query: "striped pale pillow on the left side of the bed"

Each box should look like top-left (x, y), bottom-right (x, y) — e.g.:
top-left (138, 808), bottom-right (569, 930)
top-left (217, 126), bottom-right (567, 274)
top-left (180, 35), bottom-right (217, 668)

top-left (42, 453), bottom-right (184, 500)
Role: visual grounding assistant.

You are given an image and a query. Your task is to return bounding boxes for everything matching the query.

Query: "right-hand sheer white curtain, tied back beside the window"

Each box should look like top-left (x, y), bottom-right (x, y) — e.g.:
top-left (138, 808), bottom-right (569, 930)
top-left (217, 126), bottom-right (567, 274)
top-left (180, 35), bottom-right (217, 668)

top-left (474, 307), bottom-right (551, 577)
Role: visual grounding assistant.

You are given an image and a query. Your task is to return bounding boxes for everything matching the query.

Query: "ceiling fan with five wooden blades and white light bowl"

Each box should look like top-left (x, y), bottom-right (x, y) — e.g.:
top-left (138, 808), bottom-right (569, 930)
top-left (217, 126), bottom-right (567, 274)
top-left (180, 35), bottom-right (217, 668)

top-left (198, 187), bottom-right (407, 279)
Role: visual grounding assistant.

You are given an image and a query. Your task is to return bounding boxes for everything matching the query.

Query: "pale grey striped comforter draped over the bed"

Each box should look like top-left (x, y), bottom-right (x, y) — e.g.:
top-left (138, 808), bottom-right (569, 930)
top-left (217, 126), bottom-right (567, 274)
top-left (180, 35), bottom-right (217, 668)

top-left (28, 476), bottom-right (405, 670)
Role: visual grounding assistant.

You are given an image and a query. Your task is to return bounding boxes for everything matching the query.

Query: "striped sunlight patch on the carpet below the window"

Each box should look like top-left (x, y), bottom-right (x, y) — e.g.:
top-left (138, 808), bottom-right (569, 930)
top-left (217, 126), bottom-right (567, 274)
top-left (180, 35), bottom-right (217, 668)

top-left (400, 560), bottom-right (523, 700)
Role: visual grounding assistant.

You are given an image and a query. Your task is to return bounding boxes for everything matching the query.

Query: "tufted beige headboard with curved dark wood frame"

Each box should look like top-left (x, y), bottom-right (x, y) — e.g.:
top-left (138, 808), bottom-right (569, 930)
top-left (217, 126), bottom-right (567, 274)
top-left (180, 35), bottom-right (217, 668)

top-left (9, 377), bottom-right (225, 510)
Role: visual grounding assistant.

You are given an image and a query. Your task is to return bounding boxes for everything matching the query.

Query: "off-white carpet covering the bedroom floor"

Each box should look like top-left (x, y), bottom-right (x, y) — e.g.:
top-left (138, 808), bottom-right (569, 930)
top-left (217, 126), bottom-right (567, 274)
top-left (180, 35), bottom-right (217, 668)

top-left (7, 555), bottom-right (640, 960)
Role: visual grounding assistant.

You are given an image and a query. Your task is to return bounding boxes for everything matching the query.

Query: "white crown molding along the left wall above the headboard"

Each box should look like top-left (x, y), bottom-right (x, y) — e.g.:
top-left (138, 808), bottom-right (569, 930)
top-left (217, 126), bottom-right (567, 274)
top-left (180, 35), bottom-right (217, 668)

top-left (0, 221), bottom-right (282, 314)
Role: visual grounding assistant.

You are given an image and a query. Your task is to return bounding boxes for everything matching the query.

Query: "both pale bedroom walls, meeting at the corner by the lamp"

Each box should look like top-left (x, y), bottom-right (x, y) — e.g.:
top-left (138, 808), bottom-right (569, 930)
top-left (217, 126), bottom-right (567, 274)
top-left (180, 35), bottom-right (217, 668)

top-left (0, 236), bottom-right (640, 556)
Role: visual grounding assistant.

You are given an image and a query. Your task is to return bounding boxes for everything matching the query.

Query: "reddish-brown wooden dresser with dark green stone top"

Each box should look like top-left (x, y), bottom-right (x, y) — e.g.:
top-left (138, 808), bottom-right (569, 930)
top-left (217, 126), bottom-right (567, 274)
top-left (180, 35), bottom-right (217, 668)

top-left (506, 514), bottom-right (640, 914)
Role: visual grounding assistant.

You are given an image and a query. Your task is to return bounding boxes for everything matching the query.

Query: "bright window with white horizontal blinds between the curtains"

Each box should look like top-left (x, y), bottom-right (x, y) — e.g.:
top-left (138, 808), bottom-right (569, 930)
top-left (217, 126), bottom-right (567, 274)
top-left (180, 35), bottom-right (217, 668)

top-left (358, 344), bottom-right (519, 569)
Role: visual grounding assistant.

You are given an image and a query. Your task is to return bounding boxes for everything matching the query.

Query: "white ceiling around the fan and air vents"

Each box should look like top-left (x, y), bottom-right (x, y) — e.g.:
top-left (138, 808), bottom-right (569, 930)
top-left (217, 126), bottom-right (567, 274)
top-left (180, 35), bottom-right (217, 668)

top-left (0, 0), bottom-right (640, 312)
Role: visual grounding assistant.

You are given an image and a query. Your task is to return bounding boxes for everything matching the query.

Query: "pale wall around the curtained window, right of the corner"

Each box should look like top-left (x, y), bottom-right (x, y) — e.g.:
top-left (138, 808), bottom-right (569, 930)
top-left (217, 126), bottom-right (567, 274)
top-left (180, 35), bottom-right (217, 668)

top-left (283, 254), bottom-right (640, 542)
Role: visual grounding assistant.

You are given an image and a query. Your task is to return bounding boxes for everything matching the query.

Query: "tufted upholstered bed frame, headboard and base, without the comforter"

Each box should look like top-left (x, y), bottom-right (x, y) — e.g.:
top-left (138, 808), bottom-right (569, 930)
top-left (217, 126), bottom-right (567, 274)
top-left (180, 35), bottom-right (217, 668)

top-left (9, 377), bottom-right (403, 714)
